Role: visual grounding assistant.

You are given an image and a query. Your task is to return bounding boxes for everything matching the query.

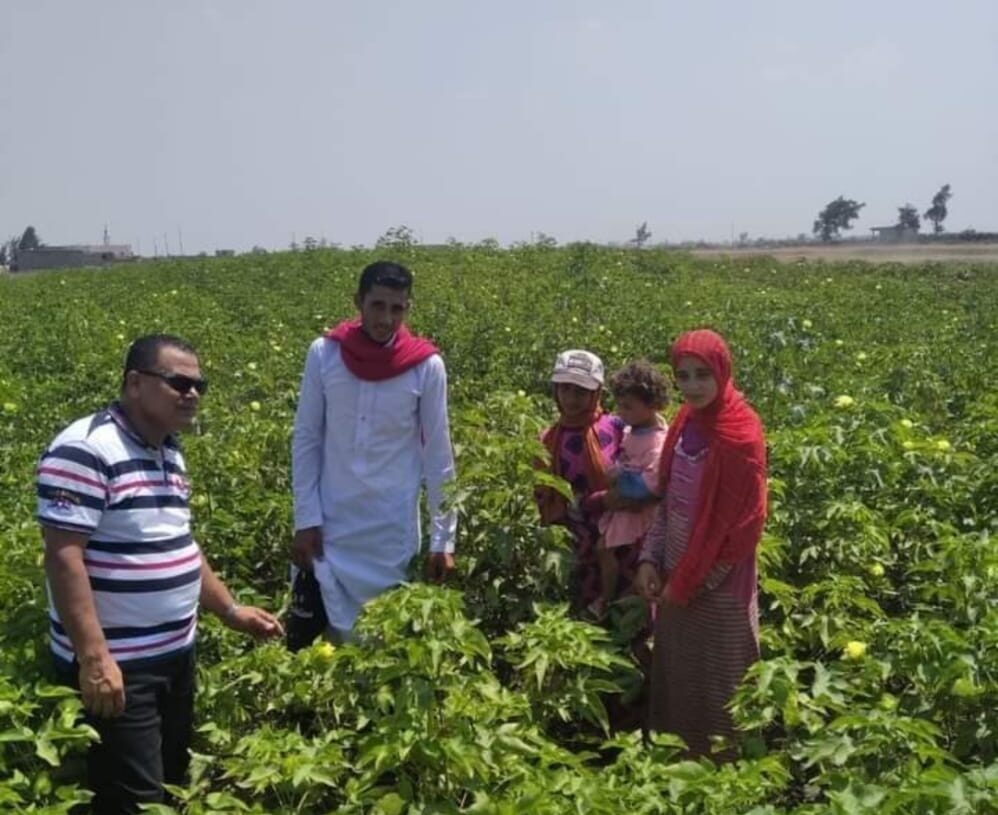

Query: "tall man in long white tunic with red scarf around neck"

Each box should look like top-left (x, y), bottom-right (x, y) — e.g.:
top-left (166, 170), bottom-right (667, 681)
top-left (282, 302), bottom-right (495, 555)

top-left (288, 261), bottom-right (456, 648)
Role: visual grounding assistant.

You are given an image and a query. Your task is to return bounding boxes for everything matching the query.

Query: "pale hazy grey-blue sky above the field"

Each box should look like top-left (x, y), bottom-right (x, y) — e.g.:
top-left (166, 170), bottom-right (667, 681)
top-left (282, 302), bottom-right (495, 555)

top-left (0, 0), bottom-right (998, 255)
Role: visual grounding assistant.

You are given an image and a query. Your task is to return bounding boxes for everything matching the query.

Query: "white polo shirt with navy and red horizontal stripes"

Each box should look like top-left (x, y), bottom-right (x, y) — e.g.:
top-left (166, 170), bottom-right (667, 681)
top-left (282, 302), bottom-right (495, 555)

top-left (37, 403), bottom-right (201, 663)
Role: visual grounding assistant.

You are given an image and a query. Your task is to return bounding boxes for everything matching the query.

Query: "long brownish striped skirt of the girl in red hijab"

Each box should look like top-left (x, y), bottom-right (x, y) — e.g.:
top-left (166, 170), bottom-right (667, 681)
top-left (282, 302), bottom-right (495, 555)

top-left (648, 590), bottom-right (759, 760)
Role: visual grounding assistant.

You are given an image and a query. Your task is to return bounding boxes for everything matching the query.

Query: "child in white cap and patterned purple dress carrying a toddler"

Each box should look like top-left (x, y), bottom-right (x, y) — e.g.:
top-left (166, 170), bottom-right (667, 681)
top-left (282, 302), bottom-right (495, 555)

top-left (536, 350), bottom-right (624, 610)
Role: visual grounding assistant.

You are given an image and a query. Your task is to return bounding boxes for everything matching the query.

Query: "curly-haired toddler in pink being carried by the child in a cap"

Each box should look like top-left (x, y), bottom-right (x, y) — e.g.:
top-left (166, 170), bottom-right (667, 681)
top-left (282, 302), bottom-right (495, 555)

top-left (589, 360), bottom-right (668, 619)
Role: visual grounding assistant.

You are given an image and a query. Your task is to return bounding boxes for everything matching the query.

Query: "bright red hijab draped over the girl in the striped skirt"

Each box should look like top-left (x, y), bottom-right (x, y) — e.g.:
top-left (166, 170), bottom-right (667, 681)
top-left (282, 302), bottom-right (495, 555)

top-left (659, 329), bottom-right (766, 605)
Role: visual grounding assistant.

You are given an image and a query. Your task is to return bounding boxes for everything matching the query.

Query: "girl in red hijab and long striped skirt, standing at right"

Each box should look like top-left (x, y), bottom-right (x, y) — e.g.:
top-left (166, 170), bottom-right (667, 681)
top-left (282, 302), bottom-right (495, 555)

top-left (635, 329), bottom-right (766, 759)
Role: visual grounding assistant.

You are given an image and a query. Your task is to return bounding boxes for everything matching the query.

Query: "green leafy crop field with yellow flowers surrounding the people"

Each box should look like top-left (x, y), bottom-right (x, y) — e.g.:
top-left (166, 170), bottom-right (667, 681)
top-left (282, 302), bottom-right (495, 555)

top-left (0, 247), bottom-right (998, 815)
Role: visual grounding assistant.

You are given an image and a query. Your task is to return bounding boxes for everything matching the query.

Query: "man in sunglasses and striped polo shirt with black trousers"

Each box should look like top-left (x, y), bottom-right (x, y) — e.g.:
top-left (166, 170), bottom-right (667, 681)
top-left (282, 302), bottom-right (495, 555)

top-left (37, 335), bottom-right (282, 813)
